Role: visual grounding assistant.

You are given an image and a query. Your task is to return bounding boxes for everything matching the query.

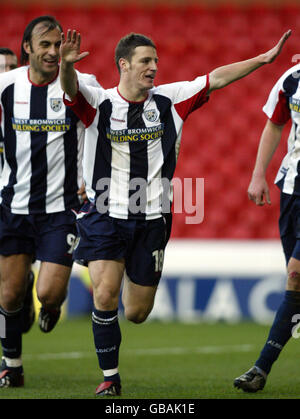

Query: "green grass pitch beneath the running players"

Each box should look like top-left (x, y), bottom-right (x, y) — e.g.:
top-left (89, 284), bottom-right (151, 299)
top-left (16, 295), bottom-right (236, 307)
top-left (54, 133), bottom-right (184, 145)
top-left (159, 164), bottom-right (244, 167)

top-left (0, 317), bottom-right (300, 400)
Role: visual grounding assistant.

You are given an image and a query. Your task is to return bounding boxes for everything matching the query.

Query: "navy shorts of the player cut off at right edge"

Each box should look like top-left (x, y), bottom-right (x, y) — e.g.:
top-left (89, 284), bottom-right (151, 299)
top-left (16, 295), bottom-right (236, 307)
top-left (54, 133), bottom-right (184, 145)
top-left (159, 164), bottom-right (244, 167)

top-left (279, 192), bottom-right (300, 263)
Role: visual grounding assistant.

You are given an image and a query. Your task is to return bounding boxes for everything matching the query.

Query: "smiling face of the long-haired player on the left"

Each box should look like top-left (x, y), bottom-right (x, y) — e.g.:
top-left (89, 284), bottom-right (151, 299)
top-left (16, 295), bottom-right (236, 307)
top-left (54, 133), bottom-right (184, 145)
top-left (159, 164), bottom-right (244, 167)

top-left (24, 23), bottom-right (61, 81)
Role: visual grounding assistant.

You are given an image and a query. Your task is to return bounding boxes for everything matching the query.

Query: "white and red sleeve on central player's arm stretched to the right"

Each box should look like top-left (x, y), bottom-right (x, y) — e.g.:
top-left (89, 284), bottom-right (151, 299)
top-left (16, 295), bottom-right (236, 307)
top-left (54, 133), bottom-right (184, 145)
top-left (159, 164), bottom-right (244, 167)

top-left (160, 74), bottom-right (209, 121)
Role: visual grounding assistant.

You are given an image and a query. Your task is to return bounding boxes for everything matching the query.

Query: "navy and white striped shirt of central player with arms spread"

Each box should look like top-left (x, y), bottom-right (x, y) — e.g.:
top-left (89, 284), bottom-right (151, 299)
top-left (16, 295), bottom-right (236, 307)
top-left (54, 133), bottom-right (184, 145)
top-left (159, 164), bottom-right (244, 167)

top-left (65, 75), bottom-right (209, 220)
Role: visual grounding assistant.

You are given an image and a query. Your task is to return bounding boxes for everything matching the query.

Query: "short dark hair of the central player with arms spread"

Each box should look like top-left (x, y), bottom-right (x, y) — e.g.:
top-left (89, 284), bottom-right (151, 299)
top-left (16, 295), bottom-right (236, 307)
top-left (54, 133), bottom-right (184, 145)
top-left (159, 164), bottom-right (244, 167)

top-left (115, 32), bottom-right (156, 73)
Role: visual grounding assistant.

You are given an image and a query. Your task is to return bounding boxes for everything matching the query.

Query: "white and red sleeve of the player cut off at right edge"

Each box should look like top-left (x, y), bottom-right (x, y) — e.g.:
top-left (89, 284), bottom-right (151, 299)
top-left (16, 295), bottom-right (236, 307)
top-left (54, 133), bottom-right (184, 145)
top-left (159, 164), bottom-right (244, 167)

top-left (263, 74), bottom-right (291, 125)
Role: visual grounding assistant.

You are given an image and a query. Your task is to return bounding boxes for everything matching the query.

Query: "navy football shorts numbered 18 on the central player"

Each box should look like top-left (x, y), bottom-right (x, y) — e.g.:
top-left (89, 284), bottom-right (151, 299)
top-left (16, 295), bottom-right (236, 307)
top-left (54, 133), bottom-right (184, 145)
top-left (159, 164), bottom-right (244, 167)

top-left (73, 204), bottom-right (172, 286)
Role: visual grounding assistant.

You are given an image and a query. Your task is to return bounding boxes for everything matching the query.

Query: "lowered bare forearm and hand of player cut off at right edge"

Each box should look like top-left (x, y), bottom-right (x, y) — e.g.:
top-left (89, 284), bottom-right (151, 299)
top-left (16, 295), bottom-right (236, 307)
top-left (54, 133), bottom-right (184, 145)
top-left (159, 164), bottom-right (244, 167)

top-left (248, 119), bottom-right (284, 206)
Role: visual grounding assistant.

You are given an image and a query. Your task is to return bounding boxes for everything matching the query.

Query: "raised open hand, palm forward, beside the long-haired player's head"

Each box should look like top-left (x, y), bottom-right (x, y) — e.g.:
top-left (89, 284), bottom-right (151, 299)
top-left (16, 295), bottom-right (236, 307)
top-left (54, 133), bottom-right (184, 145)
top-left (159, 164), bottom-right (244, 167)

top-left (59, 29), bottom-right (89, 64)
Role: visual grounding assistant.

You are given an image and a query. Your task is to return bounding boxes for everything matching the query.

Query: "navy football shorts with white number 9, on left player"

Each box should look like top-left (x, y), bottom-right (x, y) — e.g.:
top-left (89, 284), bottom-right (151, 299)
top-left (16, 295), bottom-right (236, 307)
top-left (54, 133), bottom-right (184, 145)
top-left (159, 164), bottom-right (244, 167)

top-left (0, 206), bottom-right (77, 267)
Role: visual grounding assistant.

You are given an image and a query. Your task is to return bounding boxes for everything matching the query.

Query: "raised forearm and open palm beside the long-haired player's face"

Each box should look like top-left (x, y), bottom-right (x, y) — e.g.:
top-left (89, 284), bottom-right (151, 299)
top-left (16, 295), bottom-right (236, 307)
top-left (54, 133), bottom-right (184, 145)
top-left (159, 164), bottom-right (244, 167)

top-left (60, 29), bottom-right (89, 100)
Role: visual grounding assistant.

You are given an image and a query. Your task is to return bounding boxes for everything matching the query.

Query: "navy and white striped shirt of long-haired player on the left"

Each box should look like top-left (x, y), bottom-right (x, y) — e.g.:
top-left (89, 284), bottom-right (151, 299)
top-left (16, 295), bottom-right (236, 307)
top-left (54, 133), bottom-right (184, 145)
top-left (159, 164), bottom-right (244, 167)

top-left (0, 66), bottom-right (99, 214)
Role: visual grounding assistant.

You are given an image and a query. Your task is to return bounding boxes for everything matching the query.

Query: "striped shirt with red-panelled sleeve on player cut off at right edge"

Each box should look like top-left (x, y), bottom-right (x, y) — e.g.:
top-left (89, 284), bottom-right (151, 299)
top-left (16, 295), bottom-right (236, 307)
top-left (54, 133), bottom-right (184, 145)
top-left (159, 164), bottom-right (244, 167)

top-left (263, 64), bottom-right (300, 195)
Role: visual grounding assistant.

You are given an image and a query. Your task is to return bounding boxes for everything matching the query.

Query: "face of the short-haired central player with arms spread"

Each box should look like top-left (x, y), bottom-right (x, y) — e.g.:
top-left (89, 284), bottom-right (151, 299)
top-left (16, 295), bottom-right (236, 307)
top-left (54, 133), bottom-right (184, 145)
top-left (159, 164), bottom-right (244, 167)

top-left (128, 46), bottom-right (158, 90)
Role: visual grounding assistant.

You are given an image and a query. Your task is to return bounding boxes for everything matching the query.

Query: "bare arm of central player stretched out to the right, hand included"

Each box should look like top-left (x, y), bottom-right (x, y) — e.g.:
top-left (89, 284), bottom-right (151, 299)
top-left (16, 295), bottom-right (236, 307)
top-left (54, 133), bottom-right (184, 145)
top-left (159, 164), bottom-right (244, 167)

top-left (209, 30), bottom-right (291, 93)
